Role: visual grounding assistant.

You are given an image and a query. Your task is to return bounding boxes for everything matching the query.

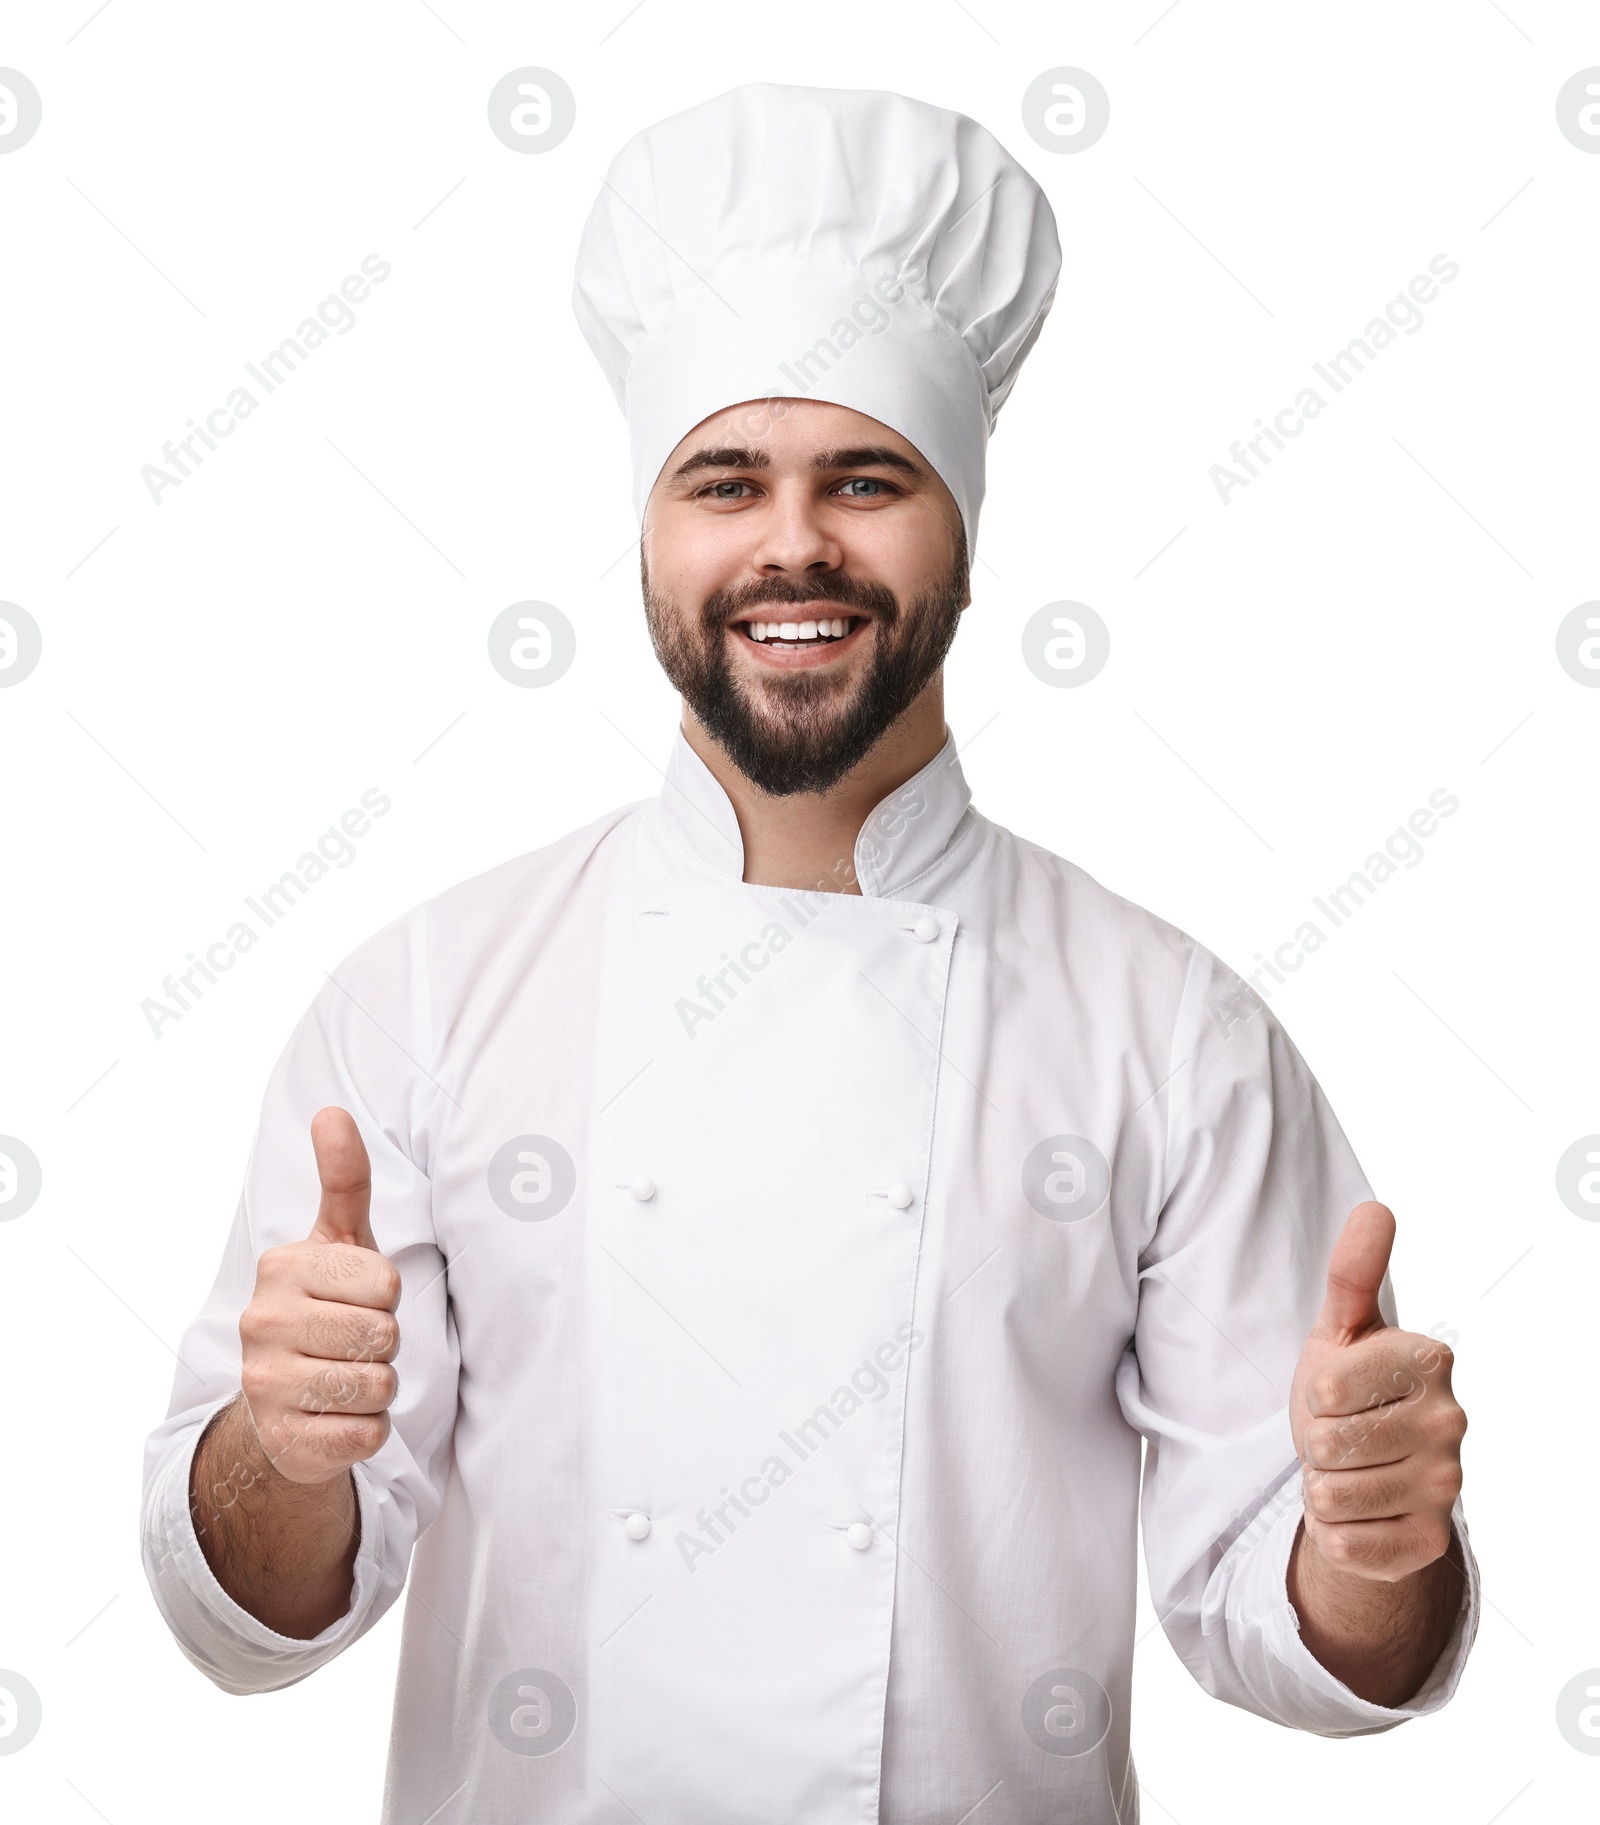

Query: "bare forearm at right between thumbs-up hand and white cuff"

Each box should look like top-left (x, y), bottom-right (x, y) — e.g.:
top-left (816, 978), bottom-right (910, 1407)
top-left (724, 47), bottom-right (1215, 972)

top-left (1288, 1524), bottom-right (1467, 1708)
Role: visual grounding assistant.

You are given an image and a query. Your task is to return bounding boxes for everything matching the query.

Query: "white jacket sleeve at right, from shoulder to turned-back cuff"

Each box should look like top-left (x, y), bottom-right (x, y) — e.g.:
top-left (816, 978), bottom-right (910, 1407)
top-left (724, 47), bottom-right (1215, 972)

top-left (1117, 951), bottom-right (1480, 1736)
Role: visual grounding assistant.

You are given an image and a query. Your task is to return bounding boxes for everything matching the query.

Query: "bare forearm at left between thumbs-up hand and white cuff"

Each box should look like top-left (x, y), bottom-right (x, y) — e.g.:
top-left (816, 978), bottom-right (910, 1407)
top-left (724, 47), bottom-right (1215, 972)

top-left (190, 1396), bottom-right (361, 1641)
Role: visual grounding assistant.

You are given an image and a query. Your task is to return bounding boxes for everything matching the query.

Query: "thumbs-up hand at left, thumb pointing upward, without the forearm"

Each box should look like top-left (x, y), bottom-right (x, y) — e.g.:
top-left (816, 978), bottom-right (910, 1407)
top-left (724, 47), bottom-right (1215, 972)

top-left (239, 1108), bottom-right (400, 1484)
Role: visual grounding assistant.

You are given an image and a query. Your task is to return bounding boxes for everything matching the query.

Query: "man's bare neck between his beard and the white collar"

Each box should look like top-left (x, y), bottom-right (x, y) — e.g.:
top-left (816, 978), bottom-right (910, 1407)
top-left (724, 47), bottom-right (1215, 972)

top-left (682, 677), bottom-right (945, 894)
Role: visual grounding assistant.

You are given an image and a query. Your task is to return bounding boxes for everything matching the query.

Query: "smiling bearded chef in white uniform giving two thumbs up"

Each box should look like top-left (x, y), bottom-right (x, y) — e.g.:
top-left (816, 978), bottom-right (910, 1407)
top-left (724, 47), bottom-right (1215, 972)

top-left (144, 84), bottom-right (1478, 1825)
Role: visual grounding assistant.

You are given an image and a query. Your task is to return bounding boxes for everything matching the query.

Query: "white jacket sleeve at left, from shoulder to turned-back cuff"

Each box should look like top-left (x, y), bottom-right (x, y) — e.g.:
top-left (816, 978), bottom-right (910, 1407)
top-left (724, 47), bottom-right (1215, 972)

top-left (142, 909), bottom-right (460, 1694)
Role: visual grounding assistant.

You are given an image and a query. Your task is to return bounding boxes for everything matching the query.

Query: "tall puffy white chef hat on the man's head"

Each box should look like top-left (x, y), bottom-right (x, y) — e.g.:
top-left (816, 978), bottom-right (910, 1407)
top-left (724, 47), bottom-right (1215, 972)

top-left (573, 82), bottom-right (1062, 551)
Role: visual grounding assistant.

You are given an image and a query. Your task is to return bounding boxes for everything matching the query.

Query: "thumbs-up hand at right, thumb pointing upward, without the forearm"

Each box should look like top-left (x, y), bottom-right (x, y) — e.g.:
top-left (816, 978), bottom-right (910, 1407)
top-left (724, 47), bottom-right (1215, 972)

top-left (1290, 1205), bottom-right (1467, 1584)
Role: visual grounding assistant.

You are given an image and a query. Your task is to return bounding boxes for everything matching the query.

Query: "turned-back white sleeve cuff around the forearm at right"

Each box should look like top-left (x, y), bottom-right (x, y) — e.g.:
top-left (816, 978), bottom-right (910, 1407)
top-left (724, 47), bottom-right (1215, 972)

top-left (1228, 1478), bottom-right (1481, 1736)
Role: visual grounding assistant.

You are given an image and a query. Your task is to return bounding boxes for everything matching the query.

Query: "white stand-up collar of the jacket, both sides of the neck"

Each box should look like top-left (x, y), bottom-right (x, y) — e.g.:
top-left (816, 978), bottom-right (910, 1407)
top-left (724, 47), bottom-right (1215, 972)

top-left (660, 732), bottom-right (972, 900)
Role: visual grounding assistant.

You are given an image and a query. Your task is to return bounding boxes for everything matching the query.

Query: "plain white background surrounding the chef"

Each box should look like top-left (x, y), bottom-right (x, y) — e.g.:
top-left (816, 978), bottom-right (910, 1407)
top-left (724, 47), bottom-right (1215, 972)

top-left (0, 0), bottom-right (1600, 1825)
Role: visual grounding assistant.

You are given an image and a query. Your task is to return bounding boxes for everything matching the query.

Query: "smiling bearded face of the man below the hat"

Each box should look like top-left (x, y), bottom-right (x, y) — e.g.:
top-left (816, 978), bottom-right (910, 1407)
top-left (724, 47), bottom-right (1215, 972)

top-left (640, 400), bottom-right (971, 796)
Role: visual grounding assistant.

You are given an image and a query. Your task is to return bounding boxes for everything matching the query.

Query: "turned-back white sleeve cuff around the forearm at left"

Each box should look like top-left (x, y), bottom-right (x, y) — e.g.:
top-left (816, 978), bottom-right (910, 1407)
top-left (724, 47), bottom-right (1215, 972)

top-left (144, 1396), bottom-right (383, 1694)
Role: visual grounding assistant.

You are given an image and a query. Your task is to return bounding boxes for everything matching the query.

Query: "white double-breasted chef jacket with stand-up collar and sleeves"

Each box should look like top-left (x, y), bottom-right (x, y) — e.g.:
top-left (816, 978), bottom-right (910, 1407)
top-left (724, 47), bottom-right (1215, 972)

top-left (144, 737), bottom-right (1478, 1825)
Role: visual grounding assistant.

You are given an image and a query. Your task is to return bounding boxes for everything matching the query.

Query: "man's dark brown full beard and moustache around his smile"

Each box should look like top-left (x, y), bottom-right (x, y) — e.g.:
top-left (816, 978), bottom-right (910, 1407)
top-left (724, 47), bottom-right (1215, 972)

top-left (640, 542), bottom-right (967, 798)
